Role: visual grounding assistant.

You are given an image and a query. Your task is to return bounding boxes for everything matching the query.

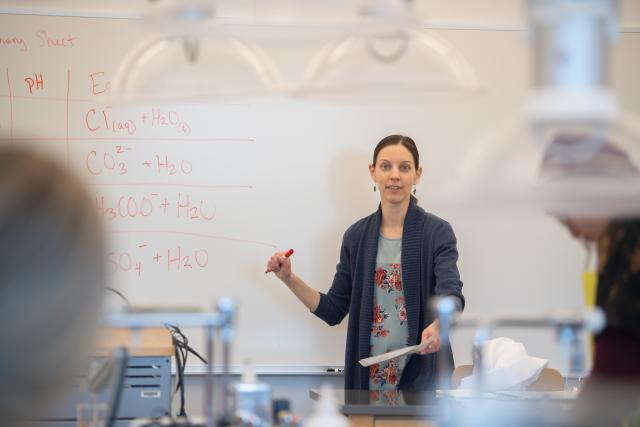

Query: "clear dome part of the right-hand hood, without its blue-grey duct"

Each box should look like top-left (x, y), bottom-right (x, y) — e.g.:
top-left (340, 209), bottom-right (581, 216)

top-left (449, 113), bottom-right (640, 218)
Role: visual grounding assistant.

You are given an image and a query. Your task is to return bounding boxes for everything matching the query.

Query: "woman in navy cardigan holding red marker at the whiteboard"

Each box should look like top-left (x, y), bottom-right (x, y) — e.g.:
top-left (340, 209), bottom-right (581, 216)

top-left (267, 135), bottom-right (464, 399)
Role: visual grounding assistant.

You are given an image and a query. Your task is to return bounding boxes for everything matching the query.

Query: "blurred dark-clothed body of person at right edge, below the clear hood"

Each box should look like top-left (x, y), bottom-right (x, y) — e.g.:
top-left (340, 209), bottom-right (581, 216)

top-left (565, 218), bottom-right (640, 426)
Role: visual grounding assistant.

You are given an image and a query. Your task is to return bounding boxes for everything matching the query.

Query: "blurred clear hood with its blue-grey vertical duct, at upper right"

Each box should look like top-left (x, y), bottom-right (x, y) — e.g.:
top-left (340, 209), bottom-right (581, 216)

top-left (442, 0), bottom-right (640, 218)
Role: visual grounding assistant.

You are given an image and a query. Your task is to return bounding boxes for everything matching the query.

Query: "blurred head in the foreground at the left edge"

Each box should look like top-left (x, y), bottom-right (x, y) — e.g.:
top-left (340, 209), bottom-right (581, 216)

top-left (0, 146), bottom-right (105, 425)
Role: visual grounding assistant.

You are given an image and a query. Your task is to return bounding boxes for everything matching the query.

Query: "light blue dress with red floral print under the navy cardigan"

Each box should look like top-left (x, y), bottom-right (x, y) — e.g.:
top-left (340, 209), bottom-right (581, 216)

top-left (369, 235), bottom-right (409, 404)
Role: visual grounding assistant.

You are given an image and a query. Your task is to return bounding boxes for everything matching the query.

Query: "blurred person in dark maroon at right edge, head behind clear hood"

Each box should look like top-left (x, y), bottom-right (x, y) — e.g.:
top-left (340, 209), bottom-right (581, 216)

top-left (540, 139), bottom-right (640, 426)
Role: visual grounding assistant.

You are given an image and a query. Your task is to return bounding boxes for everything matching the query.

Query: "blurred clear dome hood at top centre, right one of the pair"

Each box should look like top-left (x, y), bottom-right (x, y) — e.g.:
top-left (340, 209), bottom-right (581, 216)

top-left (295, 0), bottom-right (480, 102)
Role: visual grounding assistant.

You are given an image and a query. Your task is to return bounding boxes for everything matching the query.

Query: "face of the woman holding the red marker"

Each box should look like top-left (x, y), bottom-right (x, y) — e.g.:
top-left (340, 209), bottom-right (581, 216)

top-left (369, 144), bottom-right (422, 208)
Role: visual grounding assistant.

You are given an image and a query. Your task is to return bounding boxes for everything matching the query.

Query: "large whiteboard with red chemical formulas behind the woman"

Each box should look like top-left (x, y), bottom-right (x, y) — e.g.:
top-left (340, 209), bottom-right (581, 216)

top-left (0, 15), bottom-right (640, 369)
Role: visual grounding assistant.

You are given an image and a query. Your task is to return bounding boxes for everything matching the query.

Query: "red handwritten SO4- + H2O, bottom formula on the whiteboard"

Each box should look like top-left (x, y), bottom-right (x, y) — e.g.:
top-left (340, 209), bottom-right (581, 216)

top-left (107, 247), bottom-right (209, 277)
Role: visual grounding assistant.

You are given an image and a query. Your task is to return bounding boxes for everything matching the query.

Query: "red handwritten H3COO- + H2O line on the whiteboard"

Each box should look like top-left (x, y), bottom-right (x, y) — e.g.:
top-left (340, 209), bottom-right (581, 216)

top-left (94, 193), bottom-right (217, 221)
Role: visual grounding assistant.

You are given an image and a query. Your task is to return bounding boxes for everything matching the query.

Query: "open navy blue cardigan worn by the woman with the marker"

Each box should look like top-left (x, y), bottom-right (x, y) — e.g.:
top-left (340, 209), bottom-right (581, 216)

top-left (314, 198), bottom-right (464, 390)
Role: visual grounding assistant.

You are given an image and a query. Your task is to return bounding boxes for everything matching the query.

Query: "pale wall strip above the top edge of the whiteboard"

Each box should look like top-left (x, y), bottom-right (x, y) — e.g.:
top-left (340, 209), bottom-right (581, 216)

top-left (0, 0), bottom-right (640, 32)
